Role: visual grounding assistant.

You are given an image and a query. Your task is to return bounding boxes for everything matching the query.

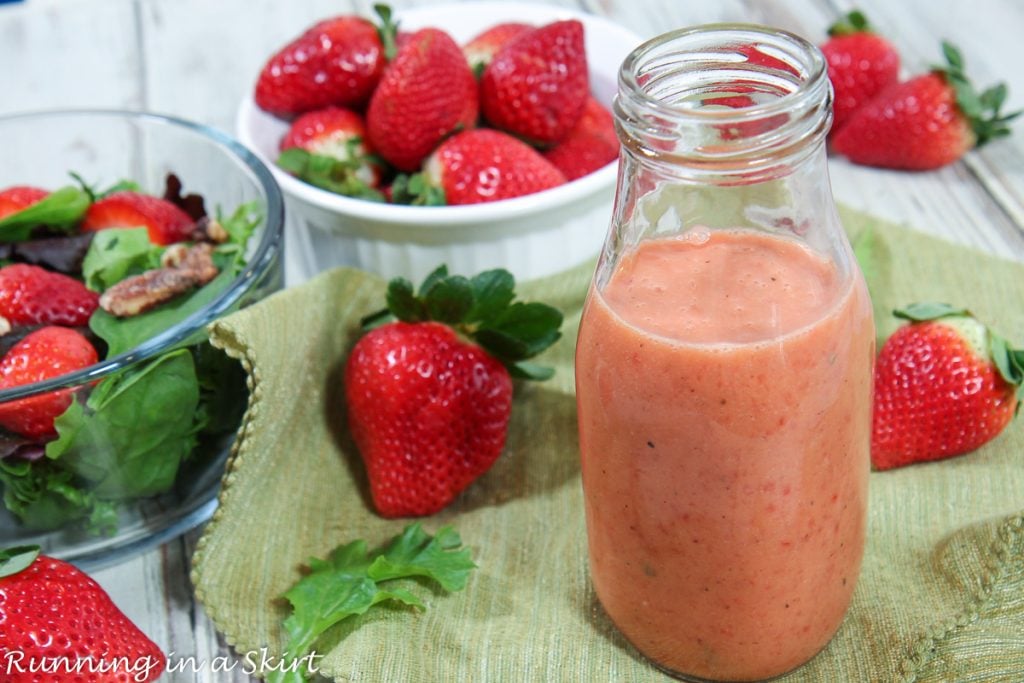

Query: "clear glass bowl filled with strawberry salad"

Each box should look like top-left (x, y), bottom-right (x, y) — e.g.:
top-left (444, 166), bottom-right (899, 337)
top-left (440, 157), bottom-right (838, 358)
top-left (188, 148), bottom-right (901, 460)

top-left (0, 111), bottom-right (284, 566)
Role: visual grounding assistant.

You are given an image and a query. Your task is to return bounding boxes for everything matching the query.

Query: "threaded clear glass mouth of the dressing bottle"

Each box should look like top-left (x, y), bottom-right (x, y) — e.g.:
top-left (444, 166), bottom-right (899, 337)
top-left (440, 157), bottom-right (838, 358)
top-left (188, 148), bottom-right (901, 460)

top-left (613, 24), bottom-right (831, 172)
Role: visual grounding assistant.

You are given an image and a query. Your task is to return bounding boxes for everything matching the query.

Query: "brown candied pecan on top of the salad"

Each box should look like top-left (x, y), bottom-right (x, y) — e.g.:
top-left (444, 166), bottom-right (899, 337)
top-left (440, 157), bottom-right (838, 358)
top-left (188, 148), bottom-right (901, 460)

top-left (99, 242), bottom-right (218, 317)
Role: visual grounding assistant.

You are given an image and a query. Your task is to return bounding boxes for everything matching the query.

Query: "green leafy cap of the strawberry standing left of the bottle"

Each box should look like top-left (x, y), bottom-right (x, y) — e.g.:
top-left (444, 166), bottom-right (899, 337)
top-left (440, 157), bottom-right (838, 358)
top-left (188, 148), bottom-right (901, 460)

top-left (362, 265), bottom-right (562, 380)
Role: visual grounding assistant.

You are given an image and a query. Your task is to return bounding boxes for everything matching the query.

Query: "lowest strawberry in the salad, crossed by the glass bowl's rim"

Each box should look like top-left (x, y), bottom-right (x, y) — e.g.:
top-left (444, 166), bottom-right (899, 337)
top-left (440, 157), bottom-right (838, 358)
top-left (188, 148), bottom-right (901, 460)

top-left (0, 327), bottom-right (98, 438)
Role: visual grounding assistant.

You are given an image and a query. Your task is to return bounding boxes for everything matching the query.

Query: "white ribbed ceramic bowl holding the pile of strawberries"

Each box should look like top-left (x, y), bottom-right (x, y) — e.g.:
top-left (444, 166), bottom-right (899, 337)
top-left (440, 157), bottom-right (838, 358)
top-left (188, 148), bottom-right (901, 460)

top-left (237, 2), bottom-right (642, 281)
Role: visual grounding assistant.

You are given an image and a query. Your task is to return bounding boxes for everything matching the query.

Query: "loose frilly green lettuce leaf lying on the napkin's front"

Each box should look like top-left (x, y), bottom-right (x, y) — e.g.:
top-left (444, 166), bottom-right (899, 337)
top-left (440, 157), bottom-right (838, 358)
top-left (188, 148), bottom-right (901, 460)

top-left (268, 523), bottom-right (476, 682)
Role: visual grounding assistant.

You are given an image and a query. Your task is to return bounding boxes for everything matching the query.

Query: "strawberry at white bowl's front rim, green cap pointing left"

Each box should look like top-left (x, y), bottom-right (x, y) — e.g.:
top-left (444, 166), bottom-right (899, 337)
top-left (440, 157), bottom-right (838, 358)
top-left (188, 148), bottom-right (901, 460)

top-left (401, 128), bottom-right (565, 205)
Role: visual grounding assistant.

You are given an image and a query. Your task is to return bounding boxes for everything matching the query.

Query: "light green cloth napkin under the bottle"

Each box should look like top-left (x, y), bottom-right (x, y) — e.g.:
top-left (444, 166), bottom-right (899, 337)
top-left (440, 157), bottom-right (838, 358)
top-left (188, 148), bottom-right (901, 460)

top-left (193, 206), bottom-right (1024, 683)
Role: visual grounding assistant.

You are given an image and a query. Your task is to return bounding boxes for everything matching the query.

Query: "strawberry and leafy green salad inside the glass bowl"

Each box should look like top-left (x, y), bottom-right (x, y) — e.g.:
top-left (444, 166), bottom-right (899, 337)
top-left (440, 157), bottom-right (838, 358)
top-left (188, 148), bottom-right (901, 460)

top-left (0, 176), bottom-right (262, 533)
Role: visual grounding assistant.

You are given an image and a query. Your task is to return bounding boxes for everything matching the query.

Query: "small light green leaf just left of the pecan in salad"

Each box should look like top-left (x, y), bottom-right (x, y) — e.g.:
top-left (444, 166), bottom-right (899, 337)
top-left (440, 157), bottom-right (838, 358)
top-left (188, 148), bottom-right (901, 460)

top-left (82, 227), bottom-right (164, 292)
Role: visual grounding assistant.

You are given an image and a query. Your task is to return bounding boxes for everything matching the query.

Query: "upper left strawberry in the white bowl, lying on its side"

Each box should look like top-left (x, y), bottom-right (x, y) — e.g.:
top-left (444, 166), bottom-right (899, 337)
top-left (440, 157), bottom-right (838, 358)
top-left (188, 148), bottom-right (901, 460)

top-left (255, 15), bottom-right (393, 118)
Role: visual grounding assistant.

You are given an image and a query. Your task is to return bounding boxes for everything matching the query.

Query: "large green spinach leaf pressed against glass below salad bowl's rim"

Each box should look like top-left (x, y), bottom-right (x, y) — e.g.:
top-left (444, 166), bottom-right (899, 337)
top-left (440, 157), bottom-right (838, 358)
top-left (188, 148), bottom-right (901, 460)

top-left (46, 349), bottom-right (199, 500)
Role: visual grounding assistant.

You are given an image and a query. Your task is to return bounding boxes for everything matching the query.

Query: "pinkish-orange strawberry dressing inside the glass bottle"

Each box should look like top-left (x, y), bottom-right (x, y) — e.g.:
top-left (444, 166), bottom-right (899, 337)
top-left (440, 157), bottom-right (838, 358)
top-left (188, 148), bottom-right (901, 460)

top-left (577, 228), bottom-right (873, 681)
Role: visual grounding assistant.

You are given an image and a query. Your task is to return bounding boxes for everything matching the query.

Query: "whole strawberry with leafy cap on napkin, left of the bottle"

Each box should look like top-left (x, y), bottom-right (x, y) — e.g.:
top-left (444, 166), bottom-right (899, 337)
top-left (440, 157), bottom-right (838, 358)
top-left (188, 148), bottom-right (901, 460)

top-left (344, 266), bottom-right (562, 517)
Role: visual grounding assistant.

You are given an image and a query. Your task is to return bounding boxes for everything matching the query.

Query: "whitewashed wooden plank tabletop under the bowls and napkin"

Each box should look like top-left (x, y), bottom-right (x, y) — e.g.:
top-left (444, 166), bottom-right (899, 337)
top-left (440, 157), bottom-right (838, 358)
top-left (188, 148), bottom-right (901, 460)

top-left (0, 0), bottom-right (1024, 682)
